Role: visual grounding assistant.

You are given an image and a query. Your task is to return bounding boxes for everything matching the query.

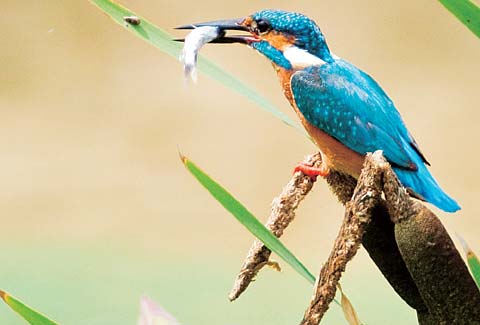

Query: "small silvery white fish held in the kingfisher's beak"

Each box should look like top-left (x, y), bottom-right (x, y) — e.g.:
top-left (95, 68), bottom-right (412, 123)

top-left (180, 26), bottom-right (222, 82)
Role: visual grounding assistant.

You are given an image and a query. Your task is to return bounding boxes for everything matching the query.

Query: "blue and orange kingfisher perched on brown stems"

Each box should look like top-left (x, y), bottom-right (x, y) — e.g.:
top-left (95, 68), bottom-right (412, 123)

top-left (179, 9), bottom-right (460, 212)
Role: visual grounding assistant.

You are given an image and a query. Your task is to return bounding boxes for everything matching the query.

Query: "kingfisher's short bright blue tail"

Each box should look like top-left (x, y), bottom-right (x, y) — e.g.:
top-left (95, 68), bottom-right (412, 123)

top-left (393, 163), bottom-right (460, 212)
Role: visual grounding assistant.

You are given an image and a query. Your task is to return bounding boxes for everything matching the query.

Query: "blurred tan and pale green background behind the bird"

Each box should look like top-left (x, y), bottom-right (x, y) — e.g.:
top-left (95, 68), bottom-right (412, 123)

top-left (0, 0), bottom-right (480, 324)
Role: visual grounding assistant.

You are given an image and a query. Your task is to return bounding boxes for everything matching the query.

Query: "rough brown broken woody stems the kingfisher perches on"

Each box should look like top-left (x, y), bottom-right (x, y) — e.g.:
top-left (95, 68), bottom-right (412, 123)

top-left (229, 152), bottom-right (480, 325)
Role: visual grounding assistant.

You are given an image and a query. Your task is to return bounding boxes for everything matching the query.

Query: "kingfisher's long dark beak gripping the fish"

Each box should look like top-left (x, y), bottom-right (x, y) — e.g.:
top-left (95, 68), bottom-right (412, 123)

top-left (175, 18), bottom-right (258, 44)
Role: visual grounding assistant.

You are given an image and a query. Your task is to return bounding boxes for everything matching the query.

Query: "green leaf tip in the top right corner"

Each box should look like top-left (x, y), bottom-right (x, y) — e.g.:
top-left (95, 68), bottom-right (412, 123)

top-left (439, 0), bottom-right (480, 38)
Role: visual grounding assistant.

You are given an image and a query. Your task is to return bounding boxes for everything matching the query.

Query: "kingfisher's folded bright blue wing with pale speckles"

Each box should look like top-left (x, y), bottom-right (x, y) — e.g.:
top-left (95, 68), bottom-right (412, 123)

top-left (291, 60), bottom-right (426, 170)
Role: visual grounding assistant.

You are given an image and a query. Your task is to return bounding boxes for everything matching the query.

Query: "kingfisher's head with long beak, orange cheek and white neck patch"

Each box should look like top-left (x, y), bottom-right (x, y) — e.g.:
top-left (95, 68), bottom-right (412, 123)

top-left (179, 9), bottom-right (333, 70)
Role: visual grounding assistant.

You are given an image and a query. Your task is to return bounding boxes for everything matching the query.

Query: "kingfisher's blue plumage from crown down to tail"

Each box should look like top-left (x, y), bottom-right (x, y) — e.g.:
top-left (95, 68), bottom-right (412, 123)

top-left (250, 10), bottom-right (460, 212)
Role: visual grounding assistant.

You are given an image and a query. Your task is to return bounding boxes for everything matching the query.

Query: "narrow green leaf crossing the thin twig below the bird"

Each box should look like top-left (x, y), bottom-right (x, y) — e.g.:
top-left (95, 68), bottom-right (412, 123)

top-left (181, 156), bottom-right (315, 284)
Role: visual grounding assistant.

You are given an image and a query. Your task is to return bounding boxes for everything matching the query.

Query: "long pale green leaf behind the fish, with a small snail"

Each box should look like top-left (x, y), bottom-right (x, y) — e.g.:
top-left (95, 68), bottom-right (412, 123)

top-left (90, 0), bottom-right (306, 134)
